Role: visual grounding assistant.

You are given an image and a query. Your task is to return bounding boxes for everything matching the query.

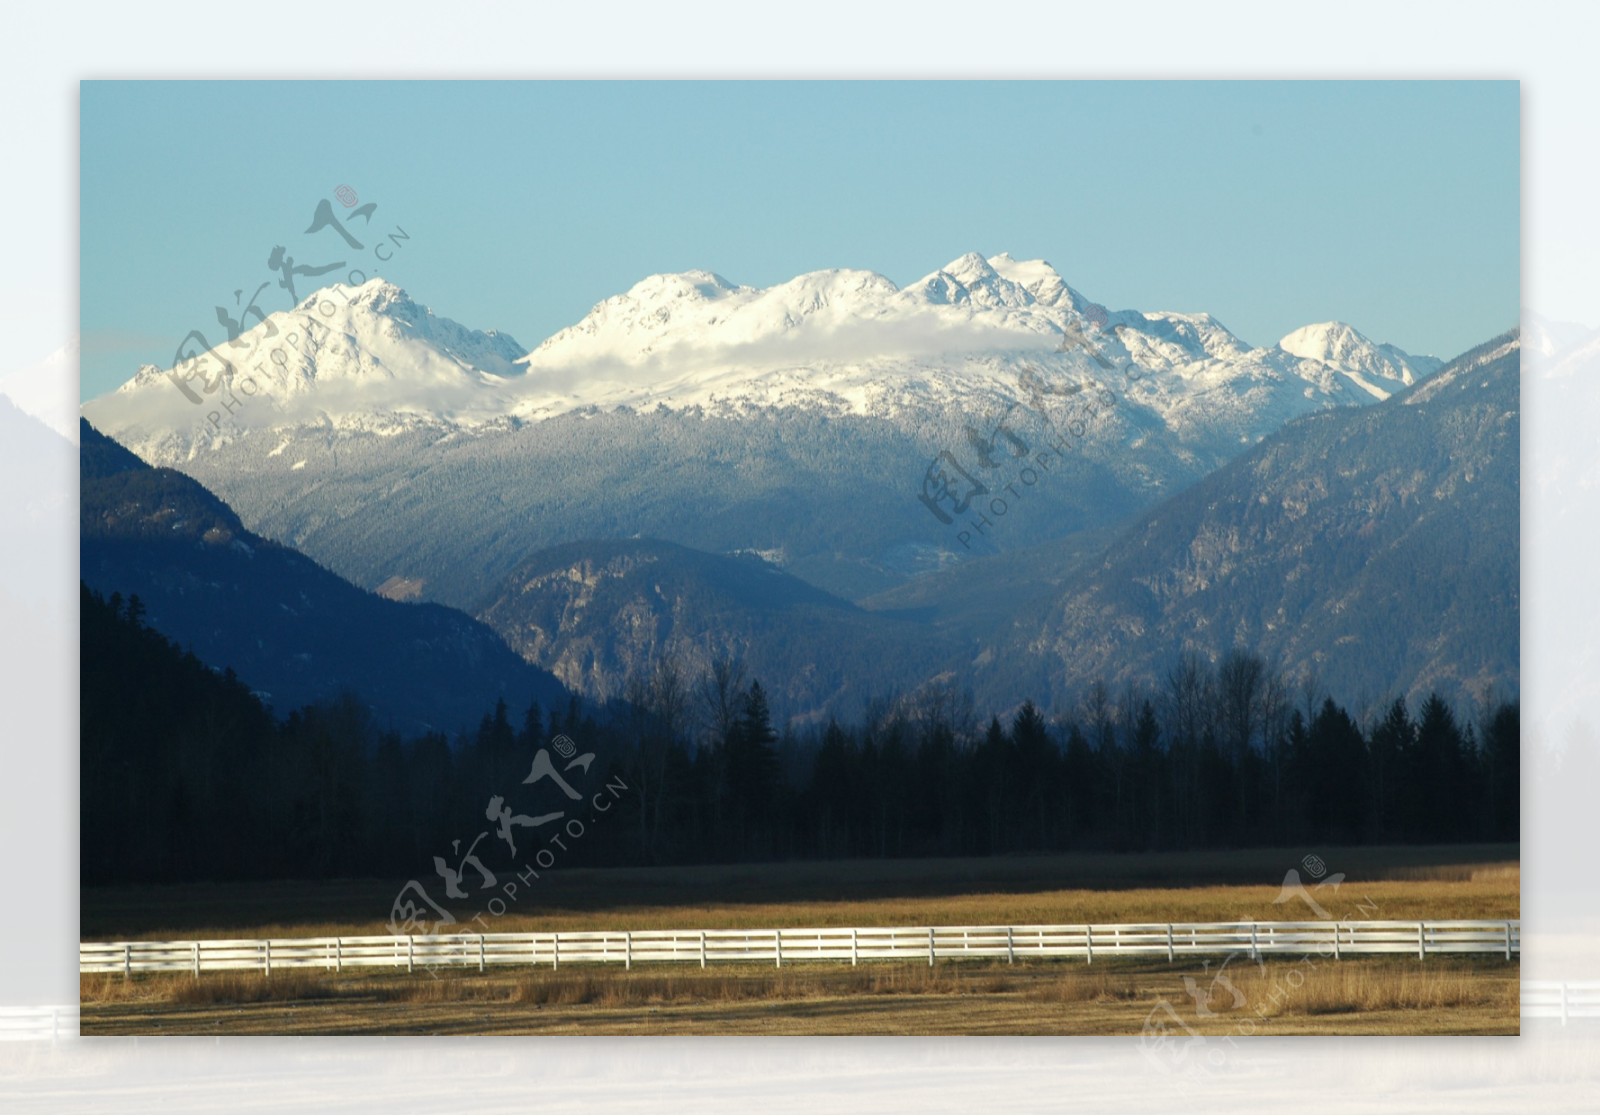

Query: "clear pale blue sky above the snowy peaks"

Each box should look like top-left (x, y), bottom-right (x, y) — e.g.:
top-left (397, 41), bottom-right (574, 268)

top-left (80, 82), bottom-right (1520, 398)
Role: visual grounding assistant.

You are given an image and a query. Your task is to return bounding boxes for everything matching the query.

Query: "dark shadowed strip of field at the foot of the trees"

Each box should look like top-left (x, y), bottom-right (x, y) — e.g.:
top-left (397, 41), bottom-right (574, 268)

top-left (80, 844), bottom-right (1518, 940)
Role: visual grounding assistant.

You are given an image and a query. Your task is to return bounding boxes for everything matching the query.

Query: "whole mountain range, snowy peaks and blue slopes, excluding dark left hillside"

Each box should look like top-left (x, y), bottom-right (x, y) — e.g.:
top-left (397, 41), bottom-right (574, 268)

top-left (85, 253), bottom-right (1518, 716)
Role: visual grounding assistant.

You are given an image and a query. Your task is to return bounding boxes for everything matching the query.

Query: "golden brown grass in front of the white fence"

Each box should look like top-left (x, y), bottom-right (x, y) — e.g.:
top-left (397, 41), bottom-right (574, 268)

top-left (82, 958), bottom-right (1518, 1034)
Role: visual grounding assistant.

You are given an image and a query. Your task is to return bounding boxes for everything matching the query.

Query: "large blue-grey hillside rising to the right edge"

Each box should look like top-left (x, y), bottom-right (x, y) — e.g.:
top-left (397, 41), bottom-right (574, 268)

top-left (979, 334), bottom-right (1522, 713)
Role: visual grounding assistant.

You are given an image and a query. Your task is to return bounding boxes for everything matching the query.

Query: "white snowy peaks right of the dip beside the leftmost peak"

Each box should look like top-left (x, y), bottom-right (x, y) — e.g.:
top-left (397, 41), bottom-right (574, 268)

top-left (515, 253), bottom-right (1440, 425)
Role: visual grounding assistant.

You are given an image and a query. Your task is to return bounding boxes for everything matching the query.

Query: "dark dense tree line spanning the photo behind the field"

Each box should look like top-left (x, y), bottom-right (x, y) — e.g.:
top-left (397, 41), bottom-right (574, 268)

top-left (82, 588), bottom-right (1520, 883)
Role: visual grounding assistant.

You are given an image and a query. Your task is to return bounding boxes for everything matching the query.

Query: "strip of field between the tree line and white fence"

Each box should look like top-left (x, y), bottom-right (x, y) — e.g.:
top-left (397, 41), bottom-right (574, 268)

top-left (82, 846), bottom-right (1520, 940)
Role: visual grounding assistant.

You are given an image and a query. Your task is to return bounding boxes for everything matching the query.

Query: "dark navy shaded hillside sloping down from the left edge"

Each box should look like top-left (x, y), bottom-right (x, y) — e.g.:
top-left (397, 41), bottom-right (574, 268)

top-left (80, 422), bottom-right (566, 731)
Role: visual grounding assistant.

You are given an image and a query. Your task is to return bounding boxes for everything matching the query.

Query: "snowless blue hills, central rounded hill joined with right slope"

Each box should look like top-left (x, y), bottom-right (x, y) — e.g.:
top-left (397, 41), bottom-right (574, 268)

top-left (478, 336), bottom-right (1520, 716)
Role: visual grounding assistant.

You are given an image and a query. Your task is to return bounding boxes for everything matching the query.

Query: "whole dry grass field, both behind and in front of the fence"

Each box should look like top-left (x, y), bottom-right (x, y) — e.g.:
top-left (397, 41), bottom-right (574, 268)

top-left (80, 846), bottom-right (1520, 1036)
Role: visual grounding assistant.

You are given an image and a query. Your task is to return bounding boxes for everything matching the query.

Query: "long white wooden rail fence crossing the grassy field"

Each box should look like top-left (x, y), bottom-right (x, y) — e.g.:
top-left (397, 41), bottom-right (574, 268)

top-left (78, 919), bottom-right (1522, 975)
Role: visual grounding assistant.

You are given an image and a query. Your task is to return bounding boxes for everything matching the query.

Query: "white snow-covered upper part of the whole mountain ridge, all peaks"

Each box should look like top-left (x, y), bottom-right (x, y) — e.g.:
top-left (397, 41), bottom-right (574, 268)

top-left (85, 253), bottom-right (1438, 462)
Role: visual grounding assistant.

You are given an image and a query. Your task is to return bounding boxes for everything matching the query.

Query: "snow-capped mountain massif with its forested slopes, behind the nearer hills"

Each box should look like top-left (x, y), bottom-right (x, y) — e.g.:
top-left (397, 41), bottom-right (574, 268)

top-left (83, 253), bottom-right (1465, 609)
